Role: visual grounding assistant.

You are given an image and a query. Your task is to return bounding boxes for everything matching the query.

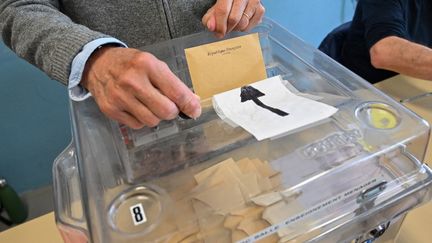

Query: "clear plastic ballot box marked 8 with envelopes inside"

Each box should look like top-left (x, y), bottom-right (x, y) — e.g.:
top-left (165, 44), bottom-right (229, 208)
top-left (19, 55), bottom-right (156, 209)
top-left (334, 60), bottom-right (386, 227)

top-left (53, 19), bottom-right (432, 243)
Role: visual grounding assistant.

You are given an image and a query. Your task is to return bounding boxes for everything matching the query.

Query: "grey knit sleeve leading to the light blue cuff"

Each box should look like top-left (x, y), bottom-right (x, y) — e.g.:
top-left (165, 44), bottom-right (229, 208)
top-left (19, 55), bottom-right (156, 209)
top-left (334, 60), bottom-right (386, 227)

top-left (0, 0), bottom-right (108, 84)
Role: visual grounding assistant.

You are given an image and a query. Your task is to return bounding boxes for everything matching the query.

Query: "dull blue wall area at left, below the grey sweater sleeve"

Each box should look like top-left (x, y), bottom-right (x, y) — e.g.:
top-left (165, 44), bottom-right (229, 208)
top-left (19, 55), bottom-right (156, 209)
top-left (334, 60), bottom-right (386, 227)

top-left (0, 42), bottom-right (70, 192)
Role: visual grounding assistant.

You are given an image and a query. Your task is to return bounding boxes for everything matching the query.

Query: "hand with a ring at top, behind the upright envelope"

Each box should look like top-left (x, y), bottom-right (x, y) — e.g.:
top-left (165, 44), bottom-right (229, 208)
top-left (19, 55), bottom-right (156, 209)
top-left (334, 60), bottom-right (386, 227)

top-left (202, 0), bottom-right (265, 38)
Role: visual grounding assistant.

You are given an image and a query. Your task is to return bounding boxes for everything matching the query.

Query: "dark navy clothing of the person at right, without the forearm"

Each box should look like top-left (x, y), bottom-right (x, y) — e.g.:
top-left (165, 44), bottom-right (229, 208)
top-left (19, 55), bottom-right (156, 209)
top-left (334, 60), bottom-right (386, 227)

top-left (340, 0), bottom-right (432, 83)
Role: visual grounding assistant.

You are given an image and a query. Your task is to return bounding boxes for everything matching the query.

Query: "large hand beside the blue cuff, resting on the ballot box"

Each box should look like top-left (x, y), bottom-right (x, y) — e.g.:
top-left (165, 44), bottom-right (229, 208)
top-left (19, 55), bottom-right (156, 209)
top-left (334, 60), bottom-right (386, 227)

top-left (81, 46), bottom-right (201, 129)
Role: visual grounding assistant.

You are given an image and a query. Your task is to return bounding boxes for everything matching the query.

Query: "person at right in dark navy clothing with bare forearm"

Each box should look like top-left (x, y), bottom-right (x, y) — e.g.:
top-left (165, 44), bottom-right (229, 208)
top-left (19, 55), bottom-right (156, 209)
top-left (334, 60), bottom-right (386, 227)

top-left (340, 0), bottom-right (432, 83)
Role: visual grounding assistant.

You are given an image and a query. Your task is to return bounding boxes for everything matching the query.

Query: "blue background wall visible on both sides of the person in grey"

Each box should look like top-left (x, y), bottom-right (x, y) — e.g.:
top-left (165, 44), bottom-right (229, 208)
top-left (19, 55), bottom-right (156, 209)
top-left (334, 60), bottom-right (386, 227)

top-left (0, 0), bottom-right (355, 192)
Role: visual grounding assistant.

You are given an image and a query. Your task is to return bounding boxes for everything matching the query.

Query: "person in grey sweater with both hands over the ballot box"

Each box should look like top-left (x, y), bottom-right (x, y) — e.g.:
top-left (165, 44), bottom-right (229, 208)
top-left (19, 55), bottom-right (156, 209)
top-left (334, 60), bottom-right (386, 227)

top-left (0, 0), bottom-right (245, 128)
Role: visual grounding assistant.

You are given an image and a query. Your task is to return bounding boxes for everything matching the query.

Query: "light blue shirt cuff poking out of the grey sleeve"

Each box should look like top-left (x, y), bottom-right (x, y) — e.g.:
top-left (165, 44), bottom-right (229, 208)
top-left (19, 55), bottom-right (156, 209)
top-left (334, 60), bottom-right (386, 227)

top-left (68, 37), bottom-right (127, 101)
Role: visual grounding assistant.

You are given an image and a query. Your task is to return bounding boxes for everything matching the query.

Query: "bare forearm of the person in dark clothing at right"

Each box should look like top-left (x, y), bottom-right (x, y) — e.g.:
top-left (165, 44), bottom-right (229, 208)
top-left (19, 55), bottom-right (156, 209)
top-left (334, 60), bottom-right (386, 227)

top-left (370, 36), bottom-right (432, 80)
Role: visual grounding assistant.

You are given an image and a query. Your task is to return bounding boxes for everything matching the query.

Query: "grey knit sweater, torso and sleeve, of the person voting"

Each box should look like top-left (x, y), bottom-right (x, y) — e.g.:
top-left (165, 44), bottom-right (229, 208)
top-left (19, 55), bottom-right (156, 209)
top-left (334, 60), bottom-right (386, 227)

top-left (0, 0), bottom-right (215, 84)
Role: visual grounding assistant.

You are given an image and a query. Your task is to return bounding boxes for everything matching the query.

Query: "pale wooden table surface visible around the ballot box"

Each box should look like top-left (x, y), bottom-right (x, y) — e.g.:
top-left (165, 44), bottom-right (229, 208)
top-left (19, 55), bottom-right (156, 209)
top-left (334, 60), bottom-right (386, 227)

top-left (0, 75), bottom-right (432, 243)
